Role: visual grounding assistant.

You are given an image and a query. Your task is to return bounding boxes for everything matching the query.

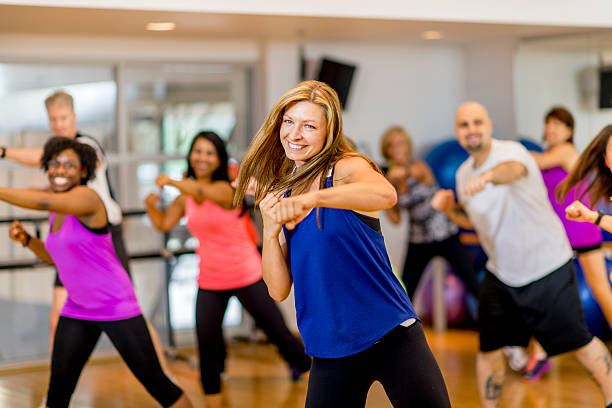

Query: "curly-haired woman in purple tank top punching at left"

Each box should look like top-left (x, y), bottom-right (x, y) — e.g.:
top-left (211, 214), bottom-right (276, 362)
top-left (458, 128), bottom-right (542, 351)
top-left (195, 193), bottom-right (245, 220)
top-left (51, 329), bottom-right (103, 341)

top-left (0, 137), bottom-right (191, 408)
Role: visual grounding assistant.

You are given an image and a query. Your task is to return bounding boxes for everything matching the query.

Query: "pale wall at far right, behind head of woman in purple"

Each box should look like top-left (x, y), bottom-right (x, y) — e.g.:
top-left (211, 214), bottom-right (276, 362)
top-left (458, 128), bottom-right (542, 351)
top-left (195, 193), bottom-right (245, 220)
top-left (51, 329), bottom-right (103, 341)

top-left (515, 38), bottom-right (612, 151)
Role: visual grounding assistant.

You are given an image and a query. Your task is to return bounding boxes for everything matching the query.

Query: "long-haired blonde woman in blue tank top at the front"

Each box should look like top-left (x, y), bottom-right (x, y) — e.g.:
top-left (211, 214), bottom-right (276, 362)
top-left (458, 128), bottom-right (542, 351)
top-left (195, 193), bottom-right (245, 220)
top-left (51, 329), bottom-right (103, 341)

top-left (234, 81), bottom-right (450, 407)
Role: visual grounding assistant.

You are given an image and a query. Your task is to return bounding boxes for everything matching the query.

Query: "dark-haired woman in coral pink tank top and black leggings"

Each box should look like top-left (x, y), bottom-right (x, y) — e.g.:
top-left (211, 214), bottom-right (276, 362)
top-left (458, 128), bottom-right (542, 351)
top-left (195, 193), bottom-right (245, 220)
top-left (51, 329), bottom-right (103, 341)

top-left (145, 132), bottom-right (310, 408)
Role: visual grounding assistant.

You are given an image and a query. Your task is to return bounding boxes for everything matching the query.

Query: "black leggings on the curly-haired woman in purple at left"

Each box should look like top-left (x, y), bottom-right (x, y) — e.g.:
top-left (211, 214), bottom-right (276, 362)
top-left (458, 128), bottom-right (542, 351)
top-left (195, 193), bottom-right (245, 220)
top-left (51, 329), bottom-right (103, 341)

top-left (47, 315), bottom-right (183, 408)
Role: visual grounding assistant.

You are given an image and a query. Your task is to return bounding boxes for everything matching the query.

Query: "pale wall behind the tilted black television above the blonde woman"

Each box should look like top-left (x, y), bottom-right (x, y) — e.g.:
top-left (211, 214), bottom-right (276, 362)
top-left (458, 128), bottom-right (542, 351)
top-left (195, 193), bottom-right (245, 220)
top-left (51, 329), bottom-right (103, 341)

top-left (265, 42), bottom-right (465, 162)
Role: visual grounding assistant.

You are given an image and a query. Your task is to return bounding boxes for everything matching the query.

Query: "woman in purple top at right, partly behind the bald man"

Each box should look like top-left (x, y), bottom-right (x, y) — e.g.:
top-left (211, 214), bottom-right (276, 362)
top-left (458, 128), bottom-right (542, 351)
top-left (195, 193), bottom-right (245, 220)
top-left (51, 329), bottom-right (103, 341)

top-left (523, 111), bottom-right (612, 379)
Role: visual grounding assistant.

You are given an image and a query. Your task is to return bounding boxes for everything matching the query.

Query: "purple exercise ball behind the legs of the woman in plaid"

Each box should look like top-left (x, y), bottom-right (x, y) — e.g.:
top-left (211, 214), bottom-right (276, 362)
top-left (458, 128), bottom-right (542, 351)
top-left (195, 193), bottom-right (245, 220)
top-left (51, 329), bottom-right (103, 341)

top-left (415, 268), bottom-right (468, 325)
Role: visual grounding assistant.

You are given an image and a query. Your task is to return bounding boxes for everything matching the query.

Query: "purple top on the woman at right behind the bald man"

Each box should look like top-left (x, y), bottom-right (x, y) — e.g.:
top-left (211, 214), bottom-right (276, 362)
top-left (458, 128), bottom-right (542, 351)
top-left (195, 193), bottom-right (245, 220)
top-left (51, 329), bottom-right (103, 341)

top-left (542, 167), bottom-right (601, 249)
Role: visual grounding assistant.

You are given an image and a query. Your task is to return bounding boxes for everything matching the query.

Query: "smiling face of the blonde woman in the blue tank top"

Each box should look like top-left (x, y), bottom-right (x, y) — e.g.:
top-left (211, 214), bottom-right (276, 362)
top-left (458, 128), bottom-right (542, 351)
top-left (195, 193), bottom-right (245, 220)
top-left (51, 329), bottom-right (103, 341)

top-left (279, 101), bottom-right (327, 167)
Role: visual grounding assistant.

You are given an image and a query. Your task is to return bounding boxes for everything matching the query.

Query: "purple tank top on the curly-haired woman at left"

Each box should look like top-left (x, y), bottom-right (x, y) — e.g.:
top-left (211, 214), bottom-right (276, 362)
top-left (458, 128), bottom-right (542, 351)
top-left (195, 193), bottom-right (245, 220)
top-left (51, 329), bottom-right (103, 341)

top-left (45, 213), bottom-right (142, 320)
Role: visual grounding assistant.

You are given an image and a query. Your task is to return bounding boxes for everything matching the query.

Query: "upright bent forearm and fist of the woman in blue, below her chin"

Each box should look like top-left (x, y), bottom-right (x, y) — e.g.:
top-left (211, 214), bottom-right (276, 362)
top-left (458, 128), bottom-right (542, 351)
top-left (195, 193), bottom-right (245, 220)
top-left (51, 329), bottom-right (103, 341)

top-left (259, 194), bottom-right (293, 302)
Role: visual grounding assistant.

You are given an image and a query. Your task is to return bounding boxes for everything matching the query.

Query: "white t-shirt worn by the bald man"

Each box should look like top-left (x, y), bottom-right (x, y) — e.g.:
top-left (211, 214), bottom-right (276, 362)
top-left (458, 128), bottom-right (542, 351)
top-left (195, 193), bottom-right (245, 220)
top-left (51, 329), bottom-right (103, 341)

top-left (456, 139), bottom-right (573, 287)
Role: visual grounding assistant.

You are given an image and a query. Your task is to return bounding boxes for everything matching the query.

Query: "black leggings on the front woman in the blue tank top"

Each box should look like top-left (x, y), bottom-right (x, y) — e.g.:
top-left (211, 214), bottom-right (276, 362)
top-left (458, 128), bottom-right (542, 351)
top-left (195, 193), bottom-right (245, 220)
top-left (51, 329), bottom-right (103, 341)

top-left (306, 321), bottom-right (450, 408)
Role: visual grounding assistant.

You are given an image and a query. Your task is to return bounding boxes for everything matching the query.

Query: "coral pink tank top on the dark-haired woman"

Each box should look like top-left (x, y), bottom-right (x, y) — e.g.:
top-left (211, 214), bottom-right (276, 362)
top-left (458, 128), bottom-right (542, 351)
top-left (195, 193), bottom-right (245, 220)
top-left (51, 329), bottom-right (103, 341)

top-left (185, 196), bottom-right (261, 290)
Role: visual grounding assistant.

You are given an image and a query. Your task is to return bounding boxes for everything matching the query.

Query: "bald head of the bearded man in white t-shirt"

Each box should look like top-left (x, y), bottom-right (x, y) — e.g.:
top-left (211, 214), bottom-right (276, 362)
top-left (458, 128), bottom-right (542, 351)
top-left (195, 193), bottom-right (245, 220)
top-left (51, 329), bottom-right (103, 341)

top-left (455, 101), bottom-right (493, 154)
